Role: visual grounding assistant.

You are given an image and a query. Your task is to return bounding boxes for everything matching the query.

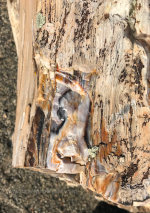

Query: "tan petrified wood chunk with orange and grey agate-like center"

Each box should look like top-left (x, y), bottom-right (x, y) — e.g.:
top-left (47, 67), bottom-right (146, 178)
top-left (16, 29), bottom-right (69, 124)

top-left (8, 0), bottom-right (150, 206)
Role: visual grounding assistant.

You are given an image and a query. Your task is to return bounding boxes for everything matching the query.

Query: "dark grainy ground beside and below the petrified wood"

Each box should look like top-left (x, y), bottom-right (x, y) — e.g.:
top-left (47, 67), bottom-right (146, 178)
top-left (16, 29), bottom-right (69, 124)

top-left (0, 0), bottom-right (131, 213)
